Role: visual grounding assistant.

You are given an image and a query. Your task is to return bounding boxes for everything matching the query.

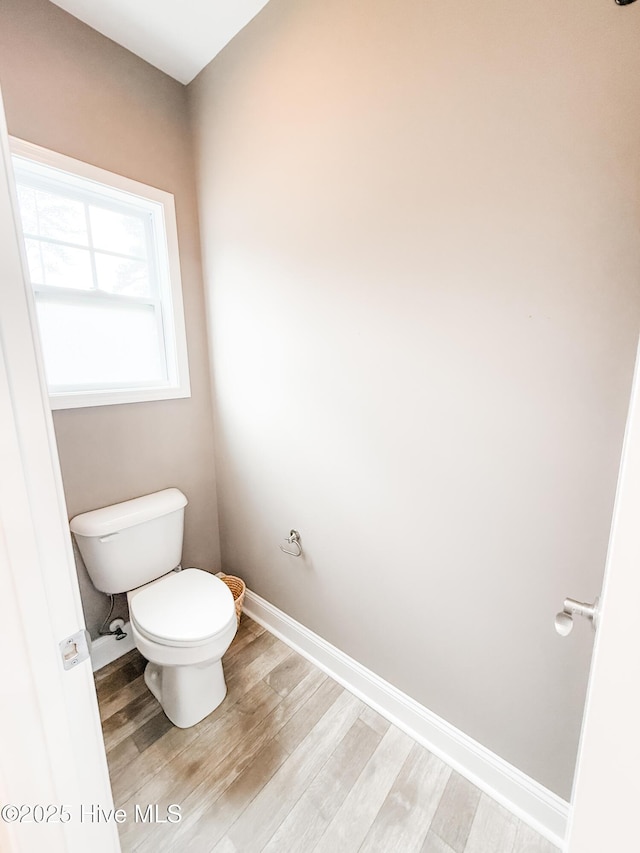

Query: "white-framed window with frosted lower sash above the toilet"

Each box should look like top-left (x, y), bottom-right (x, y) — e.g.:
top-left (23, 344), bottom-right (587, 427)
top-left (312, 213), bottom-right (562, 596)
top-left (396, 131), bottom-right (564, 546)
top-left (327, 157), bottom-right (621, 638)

top-left (11, 139), bottom-right (190, 409)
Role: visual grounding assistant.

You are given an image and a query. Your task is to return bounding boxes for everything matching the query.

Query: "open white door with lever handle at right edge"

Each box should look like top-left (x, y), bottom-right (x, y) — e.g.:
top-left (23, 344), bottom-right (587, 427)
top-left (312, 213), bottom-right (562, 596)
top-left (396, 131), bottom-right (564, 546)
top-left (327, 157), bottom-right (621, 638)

top-left (566, 336), bottom-right (640, 853)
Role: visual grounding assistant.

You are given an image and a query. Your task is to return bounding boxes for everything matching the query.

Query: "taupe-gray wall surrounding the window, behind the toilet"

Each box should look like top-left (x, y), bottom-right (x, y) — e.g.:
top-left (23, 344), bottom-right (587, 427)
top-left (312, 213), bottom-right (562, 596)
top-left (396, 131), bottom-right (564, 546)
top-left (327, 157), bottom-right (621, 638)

top-left (0, 0), bottom-right (220, 636)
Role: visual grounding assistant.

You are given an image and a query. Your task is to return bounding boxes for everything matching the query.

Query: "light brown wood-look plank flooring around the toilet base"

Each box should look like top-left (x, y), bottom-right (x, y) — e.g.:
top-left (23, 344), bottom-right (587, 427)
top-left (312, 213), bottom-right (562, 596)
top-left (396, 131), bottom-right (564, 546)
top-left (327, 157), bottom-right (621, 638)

top-left (96, 615), bottom-right (557, 853)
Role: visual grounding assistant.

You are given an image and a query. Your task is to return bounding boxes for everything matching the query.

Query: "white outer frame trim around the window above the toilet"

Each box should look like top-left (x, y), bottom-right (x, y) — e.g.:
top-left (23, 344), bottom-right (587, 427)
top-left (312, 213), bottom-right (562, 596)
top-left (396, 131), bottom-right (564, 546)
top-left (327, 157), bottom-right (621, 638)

top-left (10, 137), bottom-right (191, 409)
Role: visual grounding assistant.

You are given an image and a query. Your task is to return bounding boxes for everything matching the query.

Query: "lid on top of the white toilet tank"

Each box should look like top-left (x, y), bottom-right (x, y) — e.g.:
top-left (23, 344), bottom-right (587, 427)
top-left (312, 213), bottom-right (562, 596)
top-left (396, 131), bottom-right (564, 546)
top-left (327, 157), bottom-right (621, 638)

top-left (69, 489), bottom-right (188, 536)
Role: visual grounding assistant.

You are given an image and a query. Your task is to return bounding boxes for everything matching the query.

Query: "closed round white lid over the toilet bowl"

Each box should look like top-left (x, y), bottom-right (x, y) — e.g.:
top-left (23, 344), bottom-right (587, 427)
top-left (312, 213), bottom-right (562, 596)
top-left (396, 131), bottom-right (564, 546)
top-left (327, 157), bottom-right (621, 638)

top-left (129, 569), bottom-right (235, 645)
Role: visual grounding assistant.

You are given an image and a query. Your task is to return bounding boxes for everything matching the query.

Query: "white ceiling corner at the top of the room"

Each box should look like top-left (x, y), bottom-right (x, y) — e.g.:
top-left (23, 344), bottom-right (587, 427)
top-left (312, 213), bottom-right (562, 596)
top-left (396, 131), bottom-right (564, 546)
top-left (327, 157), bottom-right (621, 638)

top-left (51, 0), bottom-right (268, 83)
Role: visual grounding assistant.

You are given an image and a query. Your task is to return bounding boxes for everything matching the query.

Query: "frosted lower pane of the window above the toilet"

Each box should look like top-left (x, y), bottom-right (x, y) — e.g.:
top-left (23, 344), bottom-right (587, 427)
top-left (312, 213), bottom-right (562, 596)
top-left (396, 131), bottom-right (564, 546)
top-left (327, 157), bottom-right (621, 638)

top-left (37, 299), bottom-right (166, 388)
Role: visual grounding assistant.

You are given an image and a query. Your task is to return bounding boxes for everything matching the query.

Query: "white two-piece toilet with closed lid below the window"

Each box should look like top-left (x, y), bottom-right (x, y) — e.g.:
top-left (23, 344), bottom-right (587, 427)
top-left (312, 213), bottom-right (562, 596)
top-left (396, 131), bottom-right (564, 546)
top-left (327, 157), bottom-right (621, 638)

top-left (70, 489), bottom-right (237, 729)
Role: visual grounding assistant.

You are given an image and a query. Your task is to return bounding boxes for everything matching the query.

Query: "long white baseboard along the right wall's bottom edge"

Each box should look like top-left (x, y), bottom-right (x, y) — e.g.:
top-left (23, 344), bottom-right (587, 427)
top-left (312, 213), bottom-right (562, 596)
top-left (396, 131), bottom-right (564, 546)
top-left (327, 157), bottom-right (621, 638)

top-left (244, 590), bottom-right (569, 848)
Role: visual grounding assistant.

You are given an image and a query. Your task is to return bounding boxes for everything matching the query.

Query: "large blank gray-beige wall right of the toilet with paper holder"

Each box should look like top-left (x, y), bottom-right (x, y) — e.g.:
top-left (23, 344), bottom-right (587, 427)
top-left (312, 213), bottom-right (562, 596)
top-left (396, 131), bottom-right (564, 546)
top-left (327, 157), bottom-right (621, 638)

top-left (189, 0), bottom-right (640, 797)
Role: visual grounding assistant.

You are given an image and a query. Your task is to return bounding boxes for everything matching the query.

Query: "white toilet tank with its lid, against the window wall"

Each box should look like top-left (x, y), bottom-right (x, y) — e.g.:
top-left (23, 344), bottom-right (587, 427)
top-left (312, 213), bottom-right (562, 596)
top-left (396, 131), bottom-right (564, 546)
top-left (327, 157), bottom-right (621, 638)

top-left (69, 489), bottom-right (187, 593)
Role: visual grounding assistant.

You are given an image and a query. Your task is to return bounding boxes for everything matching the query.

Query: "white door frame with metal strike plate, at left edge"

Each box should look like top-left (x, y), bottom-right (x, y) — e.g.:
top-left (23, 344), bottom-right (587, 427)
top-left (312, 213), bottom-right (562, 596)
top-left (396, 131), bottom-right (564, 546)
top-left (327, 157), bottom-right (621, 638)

top-left (0, 83), bottom-right (120, 853)
